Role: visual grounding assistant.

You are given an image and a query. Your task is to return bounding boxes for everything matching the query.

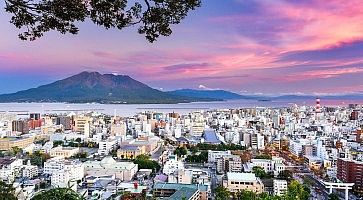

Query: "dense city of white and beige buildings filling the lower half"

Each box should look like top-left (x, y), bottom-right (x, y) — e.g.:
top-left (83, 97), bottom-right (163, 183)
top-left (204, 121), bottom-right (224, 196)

top-left (0, 99), bottom-right (363, 200)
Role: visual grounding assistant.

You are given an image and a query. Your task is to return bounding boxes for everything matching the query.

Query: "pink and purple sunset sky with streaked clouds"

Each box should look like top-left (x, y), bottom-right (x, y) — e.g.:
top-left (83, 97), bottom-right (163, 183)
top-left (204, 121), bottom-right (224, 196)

top-left (0, 0), bottom-right (363, 94)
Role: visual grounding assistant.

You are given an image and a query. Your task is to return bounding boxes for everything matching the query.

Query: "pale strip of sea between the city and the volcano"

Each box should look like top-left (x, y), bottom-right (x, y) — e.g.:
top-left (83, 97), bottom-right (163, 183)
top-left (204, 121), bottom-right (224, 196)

top-left (0, 99), bottom-right (363, 117)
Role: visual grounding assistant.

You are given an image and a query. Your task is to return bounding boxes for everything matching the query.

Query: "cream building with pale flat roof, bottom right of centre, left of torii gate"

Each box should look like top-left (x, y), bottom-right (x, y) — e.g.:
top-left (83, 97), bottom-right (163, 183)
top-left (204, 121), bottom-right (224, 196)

top-left (223, 172), bottom-right (264, 193)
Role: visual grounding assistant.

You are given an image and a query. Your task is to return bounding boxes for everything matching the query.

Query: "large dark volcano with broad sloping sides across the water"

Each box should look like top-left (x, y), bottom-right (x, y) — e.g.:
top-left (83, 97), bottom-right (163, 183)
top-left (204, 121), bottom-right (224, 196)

top-left (0, 71), bottom-right (202, 103)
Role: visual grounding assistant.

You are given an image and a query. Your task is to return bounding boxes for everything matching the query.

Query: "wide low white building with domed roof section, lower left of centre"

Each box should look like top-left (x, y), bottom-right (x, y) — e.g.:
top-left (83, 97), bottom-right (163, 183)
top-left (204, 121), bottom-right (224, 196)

top-left (84, 157), bottom-right (138, 181)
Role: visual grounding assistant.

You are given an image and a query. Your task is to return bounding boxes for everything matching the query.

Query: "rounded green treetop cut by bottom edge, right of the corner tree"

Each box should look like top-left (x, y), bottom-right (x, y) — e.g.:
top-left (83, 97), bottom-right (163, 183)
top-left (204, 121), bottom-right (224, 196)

top-left (32, 188), bottom-right (84, 200)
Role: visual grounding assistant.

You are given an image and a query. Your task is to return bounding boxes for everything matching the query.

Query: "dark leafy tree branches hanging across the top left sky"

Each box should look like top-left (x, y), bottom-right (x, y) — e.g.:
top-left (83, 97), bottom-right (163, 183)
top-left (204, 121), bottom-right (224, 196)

top-left (5, 0), bottom-right (201, 42)
